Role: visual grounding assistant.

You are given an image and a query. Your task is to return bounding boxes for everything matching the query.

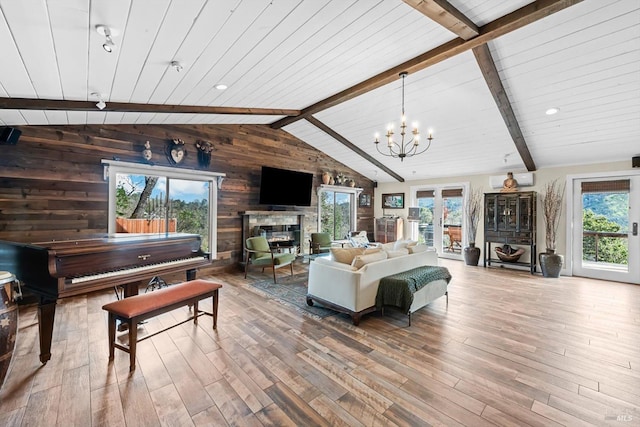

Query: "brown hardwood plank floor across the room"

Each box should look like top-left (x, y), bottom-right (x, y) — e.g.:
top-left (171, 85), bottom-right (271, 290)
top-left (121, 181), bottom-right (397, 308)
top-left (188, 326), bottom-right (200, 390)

top-left (0, 260), bottom-right (640, 426)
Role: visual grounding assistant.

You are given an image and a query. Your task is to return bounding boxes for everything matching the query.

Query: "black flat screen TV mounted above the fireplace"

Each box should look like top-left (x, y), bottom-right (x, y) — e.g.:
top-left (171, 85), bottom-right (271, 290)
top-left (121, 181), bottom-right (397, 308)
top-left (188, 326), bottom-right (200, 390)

top-left (260, 166), bottom-right (313, 206)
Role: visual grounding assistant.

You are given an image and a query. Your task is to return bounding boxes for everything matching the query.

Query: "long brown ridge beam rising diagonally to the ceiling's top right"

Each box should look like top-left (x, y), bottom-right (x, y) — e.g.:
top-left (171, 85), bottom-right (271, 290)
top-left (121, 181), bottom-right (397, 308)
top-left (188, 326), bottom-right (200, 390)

top-left (271, 0), bottom-right (582, 129)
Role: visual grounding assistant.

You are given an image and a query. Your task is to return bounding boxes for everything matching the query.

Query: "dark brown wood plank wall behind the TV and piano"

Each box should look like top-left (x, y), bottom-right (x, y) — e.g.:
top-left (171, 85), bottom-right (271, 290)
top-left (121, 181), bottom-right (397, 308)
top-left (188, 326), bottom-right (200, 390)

top-left (0, 125), bottom-right (374, 269)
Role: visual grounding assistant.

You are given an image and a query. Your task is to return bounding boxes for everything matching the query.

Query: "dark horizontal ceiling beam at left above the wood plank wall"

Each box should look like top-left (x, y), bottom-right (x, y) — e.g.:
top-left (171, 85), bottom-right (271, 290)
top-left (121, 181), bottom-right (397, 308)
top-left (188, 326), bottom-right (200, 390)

top-left (0, 98), bottom-right (300, 117)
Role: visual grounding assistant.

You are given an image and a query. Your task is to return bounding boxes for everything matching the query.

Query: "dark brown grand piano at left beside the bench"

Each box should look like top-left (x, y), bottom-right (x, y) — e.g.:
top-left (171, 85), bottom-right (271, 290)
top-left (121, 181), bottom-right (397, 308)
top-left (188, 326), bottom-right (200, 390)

top-left (0, 233), bottom-right (211, 363)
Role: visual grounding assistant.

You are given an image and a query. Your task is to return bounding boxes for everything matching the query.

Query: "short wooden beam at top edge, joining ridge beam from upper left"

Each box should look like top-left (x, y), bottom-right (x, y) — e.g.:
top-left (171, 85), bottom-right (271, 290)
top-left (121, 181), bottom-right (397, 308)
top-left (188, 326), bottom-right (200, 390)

top-left (403, 0), bottom-right (480, 40)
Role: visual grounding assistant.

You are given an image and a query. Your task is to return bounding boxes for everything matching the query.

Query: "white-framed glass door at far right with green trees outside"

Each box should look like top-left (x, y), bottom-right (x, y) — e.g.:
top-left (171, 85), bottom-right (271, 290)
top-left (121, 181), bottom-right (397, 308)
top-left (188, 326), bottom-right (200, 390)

top-left (571, 176), bottom-right (640, 283)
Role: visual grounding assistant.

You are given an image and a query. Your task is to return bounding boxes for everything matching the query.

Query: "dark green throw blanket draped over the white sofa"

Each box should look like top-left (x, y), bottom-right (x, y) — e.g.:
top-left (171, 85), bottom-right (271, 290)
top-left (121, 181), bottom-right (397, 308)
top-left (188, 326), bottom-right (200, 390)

top-left (376, 266), bottom-right (451, 314)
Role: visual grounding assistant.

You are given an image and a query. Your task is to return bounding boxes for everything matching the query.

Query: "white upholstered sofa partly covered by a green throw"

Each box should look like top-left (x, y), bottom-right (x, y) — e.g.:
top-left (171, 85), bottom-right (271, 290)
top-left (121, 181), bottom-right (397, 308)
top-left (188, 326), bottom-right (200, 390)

top-left (307, 249), bottom-right (447, 326)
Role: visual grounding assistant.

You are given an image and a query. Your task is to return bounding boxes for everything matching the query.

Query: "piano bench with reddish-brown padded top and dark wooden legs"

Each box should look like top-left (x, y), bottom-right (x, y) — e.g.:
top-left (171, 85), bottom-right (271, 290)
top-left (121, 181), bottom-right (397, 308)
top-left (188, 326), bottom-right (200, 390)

top-left (102, 279), bottom-right (222, 372)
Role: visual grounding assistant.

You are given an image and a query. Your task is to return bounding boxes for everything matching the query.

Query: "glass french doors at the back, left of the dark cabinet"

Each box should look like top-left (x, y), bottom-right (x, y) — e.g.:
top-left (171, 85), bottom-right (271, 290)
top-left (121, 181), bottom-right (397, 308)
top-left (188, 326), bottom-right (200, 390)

top-left (412, 186), bottom-right (464, 259)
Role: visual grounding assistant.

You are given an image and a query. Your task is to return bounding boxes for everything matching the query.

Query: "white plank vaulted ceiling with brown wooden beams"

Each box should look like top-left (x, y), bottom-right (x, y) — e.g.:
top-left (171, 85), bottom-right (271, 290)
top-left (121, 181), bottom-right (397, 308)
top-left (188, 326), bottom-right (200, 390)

top-left (0, 0), bottom-right (640, 182)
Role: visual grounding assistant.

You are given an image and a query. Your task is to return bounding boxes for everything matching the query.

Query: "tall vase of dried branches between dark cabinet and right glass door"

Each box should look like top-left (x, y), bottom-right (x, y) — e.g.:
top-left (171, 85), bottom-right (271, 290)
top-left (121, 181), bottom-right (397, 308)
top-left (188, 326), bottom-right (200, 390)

top-left (539, 179), bottom-right (564, 277)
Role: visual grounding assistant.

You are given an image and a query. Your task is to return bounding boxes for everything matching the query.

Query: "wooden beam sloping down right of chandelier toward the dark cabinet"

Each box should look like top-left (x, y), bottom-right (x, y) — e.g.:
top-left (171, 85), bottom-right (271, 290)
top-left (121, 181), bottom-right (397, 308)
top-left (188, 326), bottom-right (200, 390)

top-left (473, 44), bottom-right (536, 172)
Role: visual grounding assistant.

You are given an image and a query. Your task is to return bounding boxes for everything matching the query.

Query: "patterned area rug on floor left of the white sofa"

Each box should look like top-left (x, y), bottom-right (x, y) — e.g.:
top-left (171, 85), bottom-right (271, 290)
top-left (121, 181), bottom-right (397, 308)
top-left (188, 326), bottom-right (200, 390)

top-left (250, 273), bottom-right (338, 318)
